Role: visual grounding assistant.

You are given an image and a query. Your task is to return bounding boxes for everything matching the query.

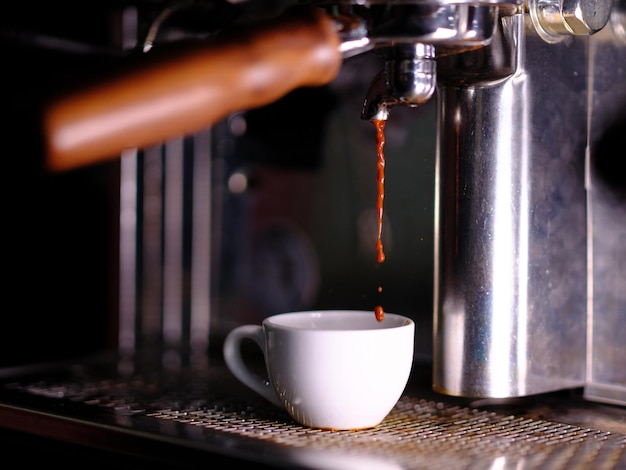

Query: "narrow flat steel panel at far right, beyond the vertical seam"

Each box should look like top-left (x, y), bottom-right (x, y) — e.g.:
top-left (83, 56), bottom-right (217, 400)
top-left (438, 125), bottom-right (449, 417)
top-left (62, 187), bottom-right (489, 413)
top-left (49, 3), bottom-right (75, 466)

top-left (585, 7), bottom-right (626, 405)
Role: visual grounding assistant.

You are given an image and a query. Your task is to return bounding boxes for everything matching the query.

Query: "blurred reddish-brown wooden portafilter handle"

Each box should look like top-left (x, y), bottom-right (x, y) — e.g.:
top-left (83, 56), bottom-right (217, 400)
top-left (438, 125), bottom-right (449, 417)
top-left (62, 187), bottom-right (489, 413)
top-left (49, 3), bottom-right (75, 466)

top-left (43, 9), bottom-right (342, 171)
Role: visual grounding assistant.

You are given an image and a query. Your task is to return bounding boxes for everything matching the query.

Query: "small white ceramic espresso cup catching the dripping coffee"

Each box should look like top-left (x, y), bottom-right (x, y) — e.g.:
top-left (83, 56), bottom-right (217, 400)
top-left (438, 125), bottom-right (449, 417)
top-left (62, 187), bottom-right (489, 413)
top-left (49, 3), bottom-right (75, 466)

top-left (224, 310), bottom-right (415, 430)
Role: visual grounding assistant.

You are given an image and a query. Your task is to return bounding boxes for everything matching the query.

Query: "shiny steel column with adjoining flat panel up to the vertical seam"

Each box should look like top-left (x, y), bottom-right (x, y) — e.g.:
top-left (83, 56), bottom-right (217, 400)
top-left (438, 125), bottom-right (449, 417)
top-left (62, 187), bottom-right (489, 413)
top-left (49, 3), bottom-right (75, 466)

top-left (434, 11), bottom-right (587, 397)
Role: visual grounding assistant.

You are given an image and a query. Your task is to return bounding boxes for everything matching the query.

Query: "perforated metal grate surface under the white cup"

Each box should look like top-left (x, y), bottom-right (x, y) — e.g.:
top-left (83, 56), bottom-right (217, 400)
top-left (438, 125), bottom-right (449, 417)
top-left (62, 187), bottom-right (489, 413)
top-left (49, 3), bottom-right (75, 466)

top-left (4, 362), bottom-right (626, 470)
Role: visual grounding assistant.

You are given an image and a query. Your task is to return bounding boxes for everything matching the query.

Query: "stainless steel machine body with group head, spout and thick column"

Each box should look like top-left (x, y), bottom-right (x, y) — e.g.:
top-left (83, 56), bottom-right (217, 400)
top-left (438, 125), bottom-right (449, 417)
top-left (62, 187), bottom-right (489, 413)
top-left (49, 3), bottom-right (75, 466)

top-left (322, 0), bottom-right (626, 404)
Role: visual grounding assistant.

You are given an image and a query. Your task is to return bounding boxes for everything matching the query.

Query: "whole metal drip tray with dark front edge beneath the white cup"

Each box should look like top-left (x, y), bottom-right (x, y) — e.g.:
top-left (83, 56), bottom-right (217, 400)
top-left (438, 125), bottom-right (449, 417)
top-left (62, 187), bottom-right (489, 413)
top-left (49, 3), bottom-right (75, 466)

top-left (0, 352), bottom-right (626, 470)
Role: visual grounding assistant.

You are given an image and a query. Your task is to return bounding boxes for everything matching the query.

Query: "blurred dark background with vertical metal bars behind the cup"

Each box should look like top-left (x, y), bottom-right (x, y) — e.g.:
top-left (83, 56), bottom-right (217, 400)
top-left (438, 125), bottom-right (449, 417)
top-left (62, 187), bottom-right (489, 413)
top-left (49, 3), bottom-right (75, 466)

top-left (0, 0), bottom-right (435, 366)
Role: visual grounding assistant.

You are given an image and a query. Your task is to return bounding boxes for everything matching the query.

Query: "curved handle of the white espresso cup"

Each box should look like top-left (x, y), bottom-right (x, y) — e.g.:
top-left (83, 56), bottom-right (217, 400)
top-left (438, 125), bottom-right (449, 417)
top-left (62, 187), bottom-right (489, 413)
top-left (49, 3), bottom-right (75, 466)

top-left (219, 325), bottom-right (282, 407)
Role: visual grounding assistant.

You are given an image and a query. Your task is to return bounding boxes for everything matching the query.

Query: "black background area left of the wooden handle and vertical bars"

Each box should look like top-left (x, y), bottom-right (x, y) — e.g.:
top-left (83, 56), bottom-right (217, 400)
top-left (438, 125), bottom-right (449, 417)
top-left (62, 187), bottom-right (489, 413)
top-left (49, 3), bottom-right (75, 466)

top-left (0, 2), bottom-right (126, 366)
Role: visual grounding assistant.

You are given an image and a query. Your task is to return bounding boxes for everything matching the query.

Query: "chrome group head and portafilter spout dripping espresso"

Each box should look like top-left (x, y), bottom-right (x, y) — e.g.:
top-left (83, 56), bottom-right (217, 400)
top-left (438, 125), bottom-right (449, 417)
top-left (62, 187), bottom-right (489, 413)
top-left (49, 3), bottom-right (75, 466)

top-left (316, 0), bottom-right (520, 120)
